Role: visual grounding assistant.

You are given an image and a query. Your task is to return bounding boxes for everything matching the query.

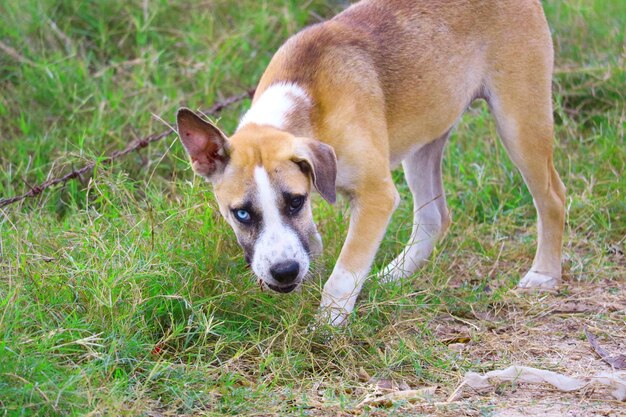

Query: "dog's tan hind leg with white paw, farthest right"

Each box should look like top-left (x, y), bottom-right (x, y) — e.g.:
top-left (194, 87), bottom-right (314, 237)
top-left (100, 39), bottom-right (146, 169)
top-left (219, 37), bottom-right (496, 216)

top-left (487, 37), bottom-right (565, 288)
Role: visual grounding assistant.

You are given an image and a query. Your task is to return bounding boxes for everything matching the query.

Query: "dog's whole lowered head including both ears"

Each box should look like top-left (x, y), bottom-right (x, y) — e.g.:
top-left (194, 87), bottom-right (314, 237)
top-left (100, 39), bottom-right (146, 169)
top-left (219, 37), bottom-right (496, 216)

top-left (177, 109), bottom-right (337, 292)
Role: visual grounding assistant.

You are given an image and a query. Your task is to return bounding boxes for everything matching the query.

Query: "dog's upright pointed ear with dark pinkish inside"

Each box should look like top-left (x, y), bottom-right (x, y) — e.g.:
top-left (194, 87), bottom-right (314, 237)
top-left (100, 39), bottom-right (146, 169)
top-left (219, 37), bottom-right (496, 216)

top-left (176, 108), bottom-right (228, 181)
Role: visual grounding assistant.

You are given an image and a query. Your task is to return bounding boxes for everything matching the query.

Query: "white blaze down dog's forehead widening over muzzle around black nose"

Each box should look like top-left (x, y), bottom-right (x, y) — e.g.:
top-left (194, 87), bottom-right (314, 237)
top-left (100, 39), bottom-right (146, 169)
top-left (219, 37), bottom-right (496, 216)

top-left (252, 167), bottom-right (309, 285)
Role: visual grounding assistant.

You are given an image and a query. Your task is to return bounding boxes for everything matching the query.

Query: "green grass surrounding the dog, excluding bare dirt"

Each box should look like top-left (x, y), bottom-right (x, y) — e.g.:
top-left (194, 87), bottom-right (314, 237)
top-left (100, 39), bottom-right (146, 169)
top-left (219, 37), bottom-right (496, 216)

top-left (0, 0), bottom-right (626, 416)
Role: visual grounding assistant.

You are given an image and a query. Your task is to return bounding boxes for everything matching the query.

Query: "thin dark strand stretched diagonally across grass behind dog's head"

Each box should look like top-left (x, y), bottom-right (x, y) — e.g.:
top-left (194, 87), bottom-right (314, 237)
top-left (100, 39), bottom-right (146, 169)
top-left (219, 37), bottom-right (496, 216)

top-left (0, 89), bottom-right (254, 208)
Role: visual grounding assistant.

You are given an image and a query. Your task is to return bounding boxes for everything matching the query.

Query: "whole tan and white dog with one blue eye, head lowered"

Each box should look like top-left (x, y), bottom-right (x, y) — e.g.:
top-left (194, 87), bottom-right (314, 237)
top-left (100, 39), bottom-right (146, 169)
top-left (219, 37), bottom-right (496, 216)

top-left (178, 0), bottom-right (565, 324)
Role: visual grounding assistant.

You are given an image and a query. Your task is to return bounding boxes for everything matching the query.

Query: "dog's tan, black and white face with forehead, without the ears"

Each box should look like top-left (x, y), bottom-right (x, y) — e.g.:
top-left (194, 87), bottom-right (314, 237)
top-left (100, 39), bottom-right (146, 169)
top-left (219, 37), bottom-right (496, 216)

top-left (207, 127), bottom-right (334, 292)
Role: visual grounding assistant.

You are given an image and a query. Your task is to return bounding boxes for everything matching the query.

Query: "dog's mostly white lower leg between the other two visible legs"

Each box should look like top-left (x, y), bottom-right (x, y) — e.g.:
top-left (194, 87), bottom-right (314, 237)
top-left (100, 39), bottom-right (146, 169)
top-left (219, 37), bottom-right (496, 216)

top-left (379, 132), bottom-right (450, 281)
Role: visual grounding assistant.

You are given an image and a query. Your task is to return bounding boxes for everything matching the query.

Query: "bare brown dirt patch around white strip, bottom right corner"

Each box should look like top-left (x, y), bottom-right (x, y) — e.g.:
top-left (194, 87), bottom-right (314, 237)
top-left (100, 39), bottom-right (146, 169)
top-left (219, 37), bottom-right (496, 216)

top-left (372, 281), bottom-right (626, 417)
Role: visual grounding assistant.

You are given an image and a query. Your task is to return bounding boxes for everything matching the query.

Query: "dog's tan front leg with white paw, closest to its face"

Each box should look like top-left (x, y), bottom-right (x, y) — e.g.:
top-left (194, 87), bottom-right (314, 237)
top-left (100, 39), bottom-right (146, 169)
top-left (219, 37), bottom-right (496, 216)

top-left (320, 180), bottom-right (400, 325)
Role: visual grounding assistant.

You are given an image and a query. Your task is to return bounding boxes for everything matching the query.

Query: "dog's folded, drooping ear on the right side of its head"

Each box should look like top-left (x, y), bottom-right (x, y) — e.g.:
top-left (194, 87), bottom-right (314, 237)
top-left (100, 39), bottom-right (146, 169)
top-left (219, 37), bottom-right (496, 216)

top-left (293, 138), bottom-right (337, 204)
